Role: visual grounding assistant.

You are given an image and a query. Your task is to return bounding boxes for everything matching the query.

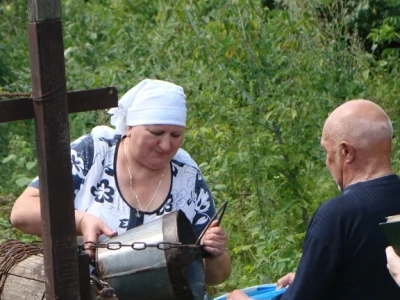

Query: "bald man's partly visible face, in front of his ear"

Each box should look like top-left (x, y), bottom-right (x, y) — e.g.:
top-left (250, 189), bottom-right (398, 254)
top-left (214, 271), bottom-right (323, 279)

top-left (321, 134), bottom-right (343, 191)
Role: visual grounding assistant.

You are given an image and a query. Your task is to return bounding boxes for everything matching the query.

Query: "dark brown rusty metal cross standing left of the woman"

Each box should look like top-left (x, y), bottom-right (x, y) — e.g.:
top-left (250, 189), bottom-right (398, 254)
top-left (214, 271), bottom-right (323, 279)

top-left (0, 0), bottom-right (118, 300)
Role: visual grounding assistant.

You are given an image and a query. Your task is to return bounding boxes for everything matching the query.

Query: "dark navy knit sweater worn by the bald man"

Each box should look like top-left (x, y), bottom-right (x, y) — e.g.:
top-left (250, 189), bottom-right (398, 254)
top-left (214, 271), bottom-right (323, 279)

top-left (274, 175), bottom-right (400, 300)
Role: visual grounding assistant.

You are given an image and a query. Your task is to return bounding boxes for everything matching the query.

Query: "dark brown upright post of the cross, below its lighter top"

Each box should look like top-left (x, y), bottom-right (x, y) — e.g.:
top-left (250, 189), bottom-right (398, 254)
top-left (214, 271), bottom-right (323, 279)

top-left (28, 17), bottom-right (80, 300)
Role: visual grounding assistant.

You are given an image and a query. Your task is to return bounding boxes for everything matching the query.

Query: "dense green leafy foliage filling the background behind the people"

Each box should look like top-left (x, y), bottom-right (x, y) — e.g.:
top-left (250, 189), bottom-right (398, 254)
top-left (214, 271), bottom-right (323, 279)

top-left (0, 0), bottom-right (400, 292)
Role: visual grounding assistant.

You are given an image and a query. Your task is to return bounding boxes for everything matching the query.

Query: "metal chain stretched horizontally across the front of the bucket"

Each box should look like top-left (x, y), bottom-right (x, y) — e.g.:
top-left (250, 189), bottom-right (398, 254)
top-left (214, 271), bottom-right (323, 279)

top-left (79, 241), bottom-right (200, 251)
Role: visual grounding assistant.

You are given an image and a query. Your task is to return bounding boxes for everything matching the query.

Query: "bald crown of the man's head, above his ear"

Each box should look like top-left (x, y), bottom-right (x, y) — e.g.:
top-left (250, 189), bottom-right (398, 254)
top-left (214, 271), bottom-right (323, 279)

top-left (323, 99), bottom-right (393, 150)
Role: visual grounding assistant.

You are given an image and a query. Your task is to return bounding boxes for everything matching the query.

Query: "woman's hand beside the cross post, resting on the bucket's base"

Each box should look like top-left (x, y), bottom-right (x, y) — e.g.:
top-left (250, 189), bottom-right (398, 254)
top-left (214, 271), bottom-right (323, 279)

top-left (77, 212), bottom-right (118, 258)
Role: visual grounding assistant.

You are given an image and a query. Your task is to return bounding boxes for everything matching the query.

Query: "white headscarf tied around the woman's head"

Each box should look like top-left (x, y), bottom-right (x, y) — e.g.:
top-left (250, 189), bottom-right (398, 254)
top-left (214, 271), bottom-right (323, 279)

top-left (108, 79), bottom-right (186, 135)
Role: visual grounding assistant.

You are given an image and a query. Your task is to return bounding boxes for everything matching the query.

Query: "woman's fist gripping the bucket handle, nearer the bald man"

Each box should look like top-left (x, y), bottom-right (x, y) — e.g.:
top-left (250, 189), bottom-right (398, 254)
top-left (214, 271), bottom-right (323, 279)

top-left (201, 220), bottom-right (228, 257)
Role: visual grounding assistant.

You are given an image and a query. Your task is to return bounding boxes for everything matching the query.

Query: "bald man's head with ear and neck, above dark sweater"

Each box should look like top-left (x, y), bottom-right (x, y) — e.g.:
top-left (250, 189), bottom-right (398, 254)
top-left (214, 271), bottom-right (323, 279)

top-left (321, 99), bottom-right (393, 190)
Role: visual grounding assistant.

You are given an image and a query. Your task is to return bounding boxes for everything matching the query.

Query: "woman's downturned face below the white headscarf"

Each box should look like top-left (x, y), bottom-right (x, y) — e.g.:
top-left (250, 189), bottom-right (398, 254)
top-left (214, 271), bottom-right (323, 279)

top-left (127, 125), bottom-right (185, 169)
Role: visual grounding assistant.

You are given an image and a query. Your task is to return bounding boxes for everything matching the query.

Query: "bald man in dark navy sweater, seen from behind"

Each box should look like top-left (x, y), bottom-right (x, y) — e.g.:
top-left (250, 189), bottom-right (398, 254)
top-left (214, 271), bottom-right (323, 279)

top-left (228, 100), bottom-right (400, 300)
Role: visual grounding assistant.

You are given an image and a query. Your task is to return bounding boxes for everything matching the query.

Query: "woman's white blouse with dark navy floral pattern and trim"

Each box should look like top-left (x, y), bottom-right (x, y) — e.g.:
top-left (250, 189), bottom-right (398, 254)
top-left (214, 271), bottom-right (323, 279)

top-left (31, 134), bottom-right (215, 240)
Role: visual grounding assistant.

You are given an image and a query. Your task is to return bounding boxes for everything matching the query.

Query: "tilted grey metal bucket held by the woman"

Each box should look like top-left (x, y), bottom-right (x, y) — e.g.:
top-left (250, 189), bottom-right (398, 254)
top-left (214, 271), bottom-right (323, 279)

top-left (96, 211), bottom-right (205, 300)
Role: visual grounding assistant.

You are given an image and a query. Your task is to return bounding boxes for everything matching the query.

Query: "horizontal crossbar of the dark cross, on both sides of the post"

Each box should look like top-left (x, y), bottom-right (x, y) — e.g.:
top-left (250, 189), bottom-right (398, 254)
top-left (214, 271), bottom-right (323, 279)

top-left (0, 87), bottom-right (118, 123)
